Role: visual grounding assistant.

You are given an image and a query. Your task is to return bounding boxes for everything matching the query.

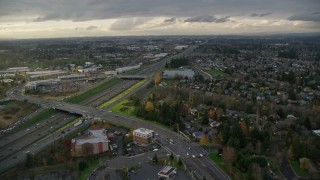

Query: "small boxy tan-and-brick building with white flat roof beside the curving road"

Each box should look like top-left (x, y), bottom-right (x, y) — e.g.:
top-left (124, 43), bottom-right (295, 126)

top-left (133, 128), bottom-right (154, 146)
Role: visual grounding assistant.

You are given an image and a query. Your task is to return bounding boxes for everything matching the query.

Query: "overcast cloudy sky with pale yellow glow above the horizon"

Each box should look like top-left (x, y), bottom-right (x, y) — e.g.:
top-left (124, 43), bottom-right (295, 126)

top-left (0, 0), bottom-right (320, 38)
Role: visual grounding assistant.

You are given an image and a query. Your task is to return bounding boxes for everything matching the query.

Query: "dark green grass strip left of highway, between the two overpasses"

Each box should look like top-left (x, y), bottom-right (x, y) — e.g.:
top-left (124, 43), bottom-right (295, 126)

top-left (64, 78), bottom-right (121, 103)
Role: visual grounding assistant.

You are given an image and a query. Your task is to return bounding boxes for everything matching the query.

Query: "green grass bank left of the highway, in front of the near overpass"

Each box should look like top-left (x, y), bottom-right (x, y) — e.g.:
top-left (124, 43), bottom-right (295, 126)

top-left (10, 108), bottom-right (55, 134)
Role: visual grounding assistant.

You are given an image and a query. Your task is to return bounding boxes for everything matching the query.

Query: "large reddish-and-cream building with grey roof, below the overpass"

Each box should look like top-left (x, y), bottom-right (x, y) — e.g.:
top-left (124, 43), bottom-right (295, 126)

top-left (71, 128), bottom-right (109, 157)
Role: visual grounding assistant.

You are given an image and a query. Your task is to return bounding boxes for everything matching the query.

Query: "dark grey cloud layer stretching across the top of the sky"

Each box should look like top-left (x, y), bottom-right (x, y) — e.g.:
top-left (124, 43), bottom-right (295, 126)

top-left (0, 0), bottom-right (320, 22)
